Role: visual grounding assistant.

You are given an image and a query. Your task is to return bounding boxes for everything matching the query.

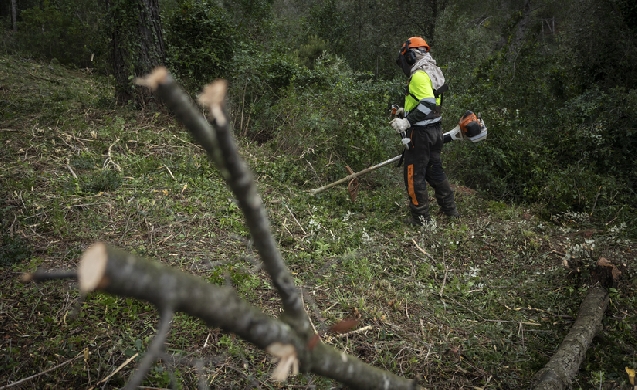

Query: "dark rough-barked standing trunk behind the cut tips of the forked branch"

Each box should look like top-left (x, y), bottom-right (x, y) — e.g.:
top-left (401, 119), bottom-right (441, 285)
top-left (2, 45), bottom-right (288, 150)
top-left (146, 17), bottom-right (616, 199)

top-left (106, 0), bottom-right (166, 107)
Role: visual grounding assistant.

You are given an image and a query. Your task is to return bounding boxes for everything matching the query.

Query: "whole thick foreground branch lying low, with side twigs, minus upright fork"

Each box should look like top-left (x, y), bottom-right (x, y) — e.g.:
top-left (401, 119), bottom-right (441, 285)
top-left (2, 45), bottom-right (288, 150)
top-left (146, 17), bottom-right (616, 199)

top-left (23, 243), bottom-right (419, 390)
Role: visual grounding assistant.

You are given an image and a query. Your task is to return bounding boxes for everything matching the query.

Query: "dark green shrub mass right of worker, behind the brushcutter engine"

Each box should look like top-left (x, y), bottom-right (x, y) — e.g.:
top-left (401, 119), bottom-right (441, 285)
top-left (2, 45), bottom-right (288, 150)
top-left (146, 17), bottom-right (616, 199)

top-left (444, 26), bottom-right (637, 229)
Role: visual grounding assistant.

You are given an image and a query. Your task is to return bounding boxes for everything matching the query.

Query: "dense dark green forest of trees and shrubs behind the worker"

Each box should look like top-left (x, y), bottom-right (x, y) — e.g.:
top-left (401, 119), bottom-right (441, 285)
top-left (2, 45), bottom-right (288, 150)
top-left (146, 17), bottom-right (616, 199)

top-left (0, 0), bottom-right (637, 232)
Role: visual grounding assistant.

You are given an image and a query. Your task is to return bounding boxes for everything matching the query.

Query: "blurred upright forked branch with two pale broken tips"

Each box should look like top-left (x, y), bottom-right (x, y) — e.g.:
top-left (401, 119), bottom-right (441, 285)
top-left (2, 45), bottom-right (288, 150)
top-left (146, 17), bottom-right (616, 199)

top-left (137, 68), bottom-right (313, 339)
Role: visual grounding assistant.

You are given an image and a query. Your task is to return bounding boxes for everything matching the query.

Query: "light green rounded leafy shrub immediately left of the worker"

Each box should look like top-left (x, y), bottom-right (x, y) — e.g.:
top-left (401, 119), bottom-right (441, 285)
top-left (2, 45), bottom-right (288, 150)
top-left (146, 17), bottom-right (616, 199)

top-left (273, 54), bottom-right (400, 184)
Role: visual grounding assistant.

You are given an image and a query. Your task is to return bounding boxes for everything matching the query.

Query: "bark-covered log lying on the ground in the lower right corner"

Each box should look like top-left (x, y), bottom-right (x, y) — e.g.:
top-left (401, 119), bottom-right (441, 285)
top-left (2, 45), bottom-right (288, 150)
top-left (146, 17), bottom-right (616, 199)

top-left (534, 287), bottom-right (608, 390)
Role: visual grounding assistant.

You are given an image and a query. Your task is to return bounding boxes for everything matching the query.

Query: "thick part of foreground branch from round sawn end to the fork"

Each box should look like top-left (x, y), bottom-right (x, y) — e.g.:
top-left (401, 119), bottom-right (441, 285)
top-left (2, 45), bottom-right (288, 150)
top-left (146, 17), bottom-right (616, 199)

top-left (78, 243), bottom-right (302, 349)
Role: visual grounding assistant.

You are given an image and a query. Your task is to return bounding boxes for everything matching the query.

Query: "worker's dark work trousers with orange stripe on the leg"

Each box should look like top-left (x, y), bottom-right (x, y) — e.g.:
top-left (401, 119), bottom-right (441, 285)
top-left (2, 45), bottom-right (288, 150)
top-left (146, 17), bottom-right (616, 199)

top-left (403, 122), bottom-right (457, 221)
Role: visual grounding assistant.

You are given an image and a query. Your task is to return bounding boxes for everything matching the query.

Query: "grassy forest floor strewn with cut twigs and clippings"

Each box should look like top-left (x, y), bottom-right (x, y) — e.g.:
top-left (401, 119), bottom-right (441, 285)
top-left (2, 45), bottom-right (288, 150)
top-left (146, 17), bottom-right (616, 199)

top-left (0, 56), bottom-right (637, 389)
